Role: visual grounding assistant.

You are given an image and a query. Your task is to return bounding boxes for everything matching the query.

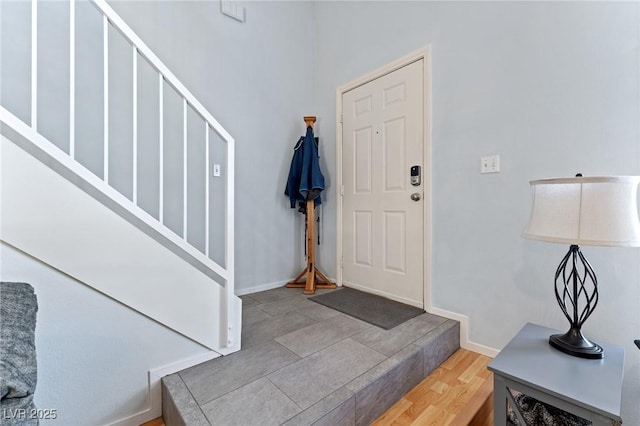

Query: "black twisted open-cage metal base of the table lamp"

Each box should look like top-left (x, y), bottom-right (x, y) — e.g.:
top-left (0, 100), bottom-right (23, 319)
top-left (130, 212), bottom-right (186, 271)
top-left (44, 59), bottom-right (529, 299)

top-left (549, 245), bottom-right (604, 359)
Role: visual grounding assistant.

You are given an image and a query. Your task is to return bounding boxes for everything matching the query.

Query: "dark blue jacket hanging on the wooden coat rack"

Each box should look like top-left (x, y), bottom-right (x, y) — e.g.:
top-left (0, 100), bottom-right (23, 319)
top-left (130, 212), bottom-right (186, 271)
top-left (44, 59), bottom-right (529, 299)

top-left (284, 126), bottom-right (324, 208)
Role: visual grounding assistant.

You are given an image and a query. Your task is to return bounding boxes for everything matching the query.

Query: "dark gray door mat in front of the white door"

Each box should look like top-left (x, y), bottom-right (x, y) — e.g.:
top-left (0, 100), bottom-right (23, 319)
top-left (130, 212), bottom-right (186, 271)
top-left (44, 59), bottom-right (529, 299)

top-left (309, 287), bottom-right (424, 330)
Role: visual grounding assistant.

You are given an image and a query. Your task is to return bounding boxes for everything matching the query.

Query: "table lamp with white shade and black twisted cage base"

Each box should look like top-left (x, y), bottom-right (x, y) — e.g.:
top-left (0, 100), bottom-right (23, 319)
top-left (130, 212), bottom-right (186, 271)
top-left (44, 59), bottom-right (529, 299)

top-left (523, 175), bottom-right (640, 359)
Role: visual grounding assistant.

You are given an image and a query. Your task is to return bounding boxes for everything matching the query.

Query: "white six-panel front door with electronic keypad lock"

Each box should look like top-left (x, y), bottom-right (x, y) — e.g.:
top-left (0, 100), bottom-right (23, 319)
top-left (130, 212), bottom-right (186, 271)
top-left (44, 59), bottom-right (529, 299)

top-left (341, 59), bottom-right (425, 307)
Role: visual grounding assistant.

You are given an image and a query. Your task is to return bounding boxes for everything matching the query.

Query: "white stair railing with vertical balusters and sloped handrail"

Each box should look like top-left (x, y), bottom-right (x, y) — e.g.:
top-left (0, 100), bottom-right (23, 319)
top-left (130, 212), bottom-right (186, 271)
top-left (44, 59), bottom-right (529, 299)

top-left (0, 0), bottom-right (237, 347)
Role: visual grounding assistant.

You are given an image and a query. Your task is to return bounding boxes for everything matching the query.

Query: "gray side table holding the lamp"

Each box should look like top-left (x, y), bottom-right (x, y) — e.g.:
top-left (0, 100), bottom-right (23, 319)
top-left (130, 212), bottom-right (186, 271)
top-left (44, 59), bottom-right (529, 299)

top-left (488, 324), bottom-right (624, 425)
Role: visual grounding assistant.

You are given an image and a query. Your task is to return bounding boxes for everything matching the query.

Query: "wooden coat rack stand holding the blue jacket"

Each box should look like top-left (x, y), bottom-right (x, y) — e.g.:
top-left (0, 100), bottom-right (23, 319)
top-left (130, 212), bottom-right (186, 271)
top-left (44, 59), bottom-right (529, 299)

top-left (286, 116), bottom-right (337, 294)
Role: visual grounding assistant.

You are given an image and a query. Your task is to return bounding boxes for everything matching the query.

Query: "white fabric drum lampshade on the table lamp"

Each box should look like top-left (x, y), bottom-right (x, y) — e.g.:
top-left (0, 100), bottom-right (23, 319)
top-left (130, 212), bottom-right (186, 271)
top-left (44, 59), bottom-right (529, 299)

top-left (523, 176), bottom-right (640, 247)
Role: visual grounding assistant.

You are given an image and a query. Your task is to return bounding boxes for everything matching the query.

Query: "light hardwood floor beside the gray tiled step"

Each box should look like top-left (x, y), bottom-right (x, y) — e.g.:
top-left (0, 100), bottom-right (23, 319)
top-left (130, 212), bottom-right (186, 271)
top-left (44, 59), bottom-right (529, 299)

top-left (142, 349), bottom-right (493, 426)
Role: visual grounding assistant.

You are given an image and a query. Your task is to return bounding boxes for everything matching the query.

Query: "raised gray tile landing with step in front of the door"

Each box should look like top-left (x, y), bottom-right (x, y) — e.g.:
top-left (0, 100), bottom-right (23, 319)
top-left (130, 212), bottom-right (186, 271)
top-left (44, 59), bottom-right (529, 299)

top-left (162, 287), bottom-right (460, 426)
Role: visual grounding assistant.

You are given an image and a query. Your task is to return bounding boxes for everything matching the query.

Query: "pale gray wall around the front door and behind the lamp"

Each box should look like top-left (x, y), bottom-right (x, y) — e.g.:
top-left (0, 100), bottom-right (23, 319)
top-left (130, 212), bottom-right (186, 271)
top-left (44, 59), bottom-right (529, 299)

top-left (314, 2), bottom-right (640, 424)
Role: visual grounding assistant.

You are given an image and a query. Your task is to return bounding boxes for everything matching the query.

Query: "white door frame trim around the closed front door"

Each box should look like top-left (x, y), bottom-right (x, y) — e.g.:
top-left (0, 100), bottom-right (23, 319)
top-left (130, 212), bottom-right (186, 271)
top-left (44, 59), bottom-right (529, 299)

top-left (336, 45), bottom-right (432, 310)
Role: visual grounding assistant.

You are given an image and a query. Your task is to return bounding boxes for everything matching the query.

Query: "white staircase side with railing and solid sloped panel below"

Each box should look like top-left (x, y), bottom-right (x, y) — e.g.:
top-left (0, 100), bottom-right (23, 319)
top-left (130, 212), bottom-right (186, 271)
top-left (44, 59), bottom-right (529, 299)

top-left (0, 0), bottom-right (242, 354)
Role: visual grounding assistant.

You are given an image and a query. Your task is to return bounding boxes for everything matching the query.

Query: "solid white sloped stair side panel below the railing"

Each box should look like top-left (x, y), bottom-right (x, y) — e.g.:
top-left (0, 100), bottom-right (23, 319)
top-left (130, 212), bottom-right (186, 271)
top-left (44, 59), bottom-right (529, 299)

top-left (0, 136), bottom-right (241, 354)
